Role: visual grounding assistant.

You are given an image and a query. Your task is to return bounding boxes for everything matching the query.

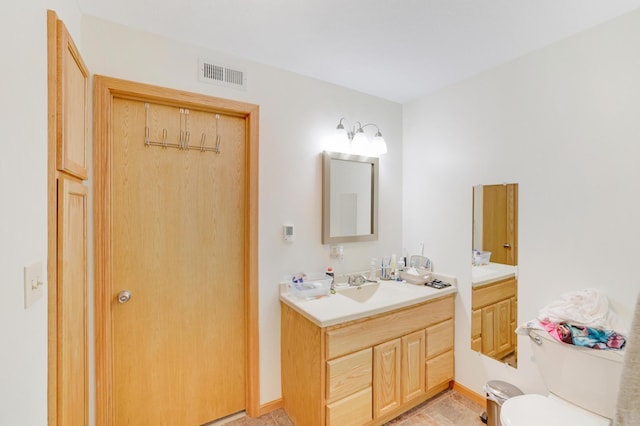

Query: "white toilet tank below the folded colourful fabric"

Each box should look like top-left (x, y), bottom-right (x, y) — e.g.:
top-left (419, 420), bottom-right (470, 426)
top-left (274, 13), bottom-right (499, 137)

top-left (529, 330), bottom-right (624, 419)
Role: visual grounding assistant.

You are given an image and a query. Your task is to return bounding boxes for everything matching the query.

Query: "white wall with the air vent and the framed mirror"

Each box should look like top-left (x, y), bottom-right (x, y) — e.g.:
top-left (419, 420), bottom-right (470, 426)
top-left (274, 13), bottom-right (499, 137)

top-left (81, 16), bottom-right (402, 410)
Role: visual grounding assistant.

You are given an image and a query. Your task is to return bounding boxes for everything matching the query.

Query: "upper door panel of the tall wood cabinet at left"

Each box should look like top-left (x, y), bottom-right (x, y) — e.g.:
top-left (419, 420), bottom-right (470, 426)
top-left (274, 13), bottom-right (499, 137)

top-left (56, 17), bottom-right (89, 179)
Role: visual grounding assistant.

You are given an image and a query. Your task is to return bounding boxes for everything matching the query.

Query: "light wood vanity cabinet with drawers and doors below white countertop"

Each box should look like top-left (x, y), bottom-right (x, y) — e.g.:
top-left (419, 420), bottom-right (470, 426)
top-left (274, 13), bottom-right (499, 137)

top-left (281, 295), bottom-right (454, 426)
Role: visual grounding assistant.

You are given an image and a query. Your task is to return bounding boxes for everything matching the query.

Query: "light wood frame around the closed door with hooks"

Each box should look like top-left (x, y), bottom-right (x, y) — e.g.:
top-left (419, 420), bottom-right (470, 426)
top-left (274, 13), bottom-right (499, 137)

top-left (93, 75), bottom-right (260, 426)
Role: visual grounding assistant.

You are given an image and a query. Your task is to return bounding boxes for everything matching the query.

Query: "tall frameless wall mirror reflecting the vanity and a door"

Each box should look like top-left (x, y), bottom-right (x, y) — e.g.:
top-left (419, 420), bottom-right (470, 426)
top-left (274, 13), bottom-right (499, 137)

top-left (471, 183), bottom-right (518, 368)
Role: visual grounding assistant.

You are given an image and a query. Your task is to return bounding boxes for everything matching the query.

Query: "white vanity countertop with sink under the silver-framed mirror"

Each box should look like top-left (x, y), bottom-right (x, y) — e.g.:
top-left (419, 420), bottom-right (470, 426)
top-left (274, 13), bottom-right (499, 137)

top-left (280, 274), bottom-right (458, 327)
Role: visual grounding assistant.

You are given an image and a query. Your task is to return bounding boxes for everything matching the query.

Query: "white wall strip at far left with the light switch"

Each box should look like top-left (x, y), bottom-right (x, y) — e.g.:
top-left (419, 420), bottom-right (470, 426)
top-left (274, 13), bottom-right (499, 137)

top-left (0, 0), bottom-right (80, 425)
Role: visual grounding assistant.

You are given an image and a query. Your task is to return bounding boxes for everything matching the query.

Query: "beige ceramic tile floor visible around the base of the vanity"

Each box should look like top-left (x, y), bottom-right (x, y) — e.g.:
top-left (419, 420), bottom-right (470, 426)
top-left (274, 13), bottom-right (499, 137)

top-left (218, 389), bottom-right (484, 426)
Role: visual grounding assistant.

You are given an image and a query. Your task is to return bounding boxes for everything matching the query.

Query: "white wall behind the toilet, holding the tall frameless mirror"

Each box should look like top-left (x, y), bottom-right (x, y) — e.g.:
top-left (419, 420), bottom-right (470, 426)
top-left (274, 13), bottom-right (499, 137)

top-left (403, 11), bottom-right (640, 393)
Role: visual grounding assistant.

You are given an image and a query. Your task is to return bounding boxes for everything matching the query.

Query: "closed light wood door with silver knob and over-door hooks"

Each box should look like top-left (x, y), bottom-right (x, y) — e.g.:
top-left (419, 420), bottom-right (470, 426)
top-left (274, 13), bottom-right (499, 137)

top-left (111, 98), bottom-right (247, 425)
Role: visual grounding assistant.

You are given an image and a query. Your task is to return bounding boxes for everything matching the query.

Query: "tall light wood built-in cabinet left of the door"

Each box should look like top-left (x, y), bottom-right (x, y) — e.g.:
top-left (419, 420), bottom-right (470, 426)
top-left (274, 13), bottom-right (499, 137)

top-left (47, 10), bottom-right (90, 426)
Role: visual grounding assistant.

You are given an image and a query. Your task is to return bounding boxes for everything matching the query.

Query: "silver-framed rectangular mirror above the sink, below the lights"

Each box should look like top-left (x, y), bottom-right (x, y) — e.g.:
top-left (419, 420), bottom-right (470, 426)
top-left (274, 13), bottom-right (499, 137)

top-left (322, 152), bottom-right (378, 244)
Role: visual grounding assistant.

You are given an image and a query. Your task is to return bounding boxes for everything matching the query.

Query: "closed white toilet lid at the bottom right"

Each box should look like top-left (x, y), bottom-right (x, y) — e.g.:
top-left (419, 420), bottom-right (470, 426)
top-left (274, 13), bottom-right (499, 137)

top-left (500, 394), bottom-right (611, 426)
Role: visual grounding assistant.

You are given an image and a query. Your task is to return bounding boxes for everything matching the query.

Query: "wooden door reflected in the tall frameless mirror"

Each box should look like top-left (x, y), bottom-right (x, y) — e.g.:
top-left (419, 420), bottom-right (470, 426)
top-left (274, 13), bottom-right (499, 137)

top-left (482, 183), bottom-right (518, 265)
